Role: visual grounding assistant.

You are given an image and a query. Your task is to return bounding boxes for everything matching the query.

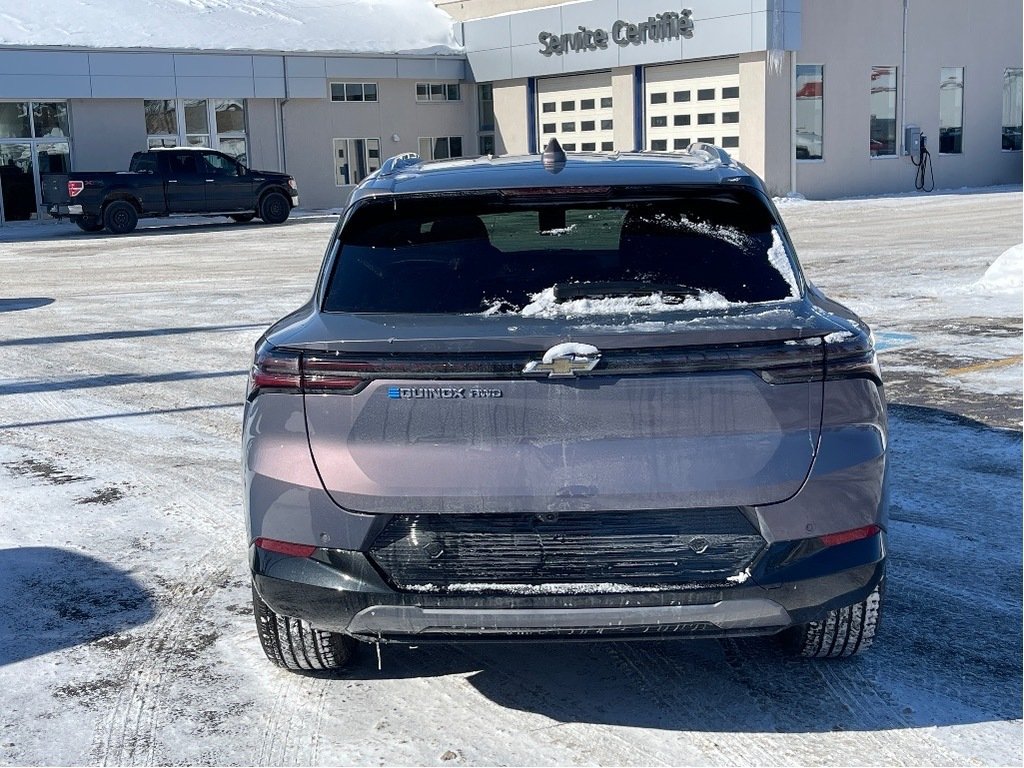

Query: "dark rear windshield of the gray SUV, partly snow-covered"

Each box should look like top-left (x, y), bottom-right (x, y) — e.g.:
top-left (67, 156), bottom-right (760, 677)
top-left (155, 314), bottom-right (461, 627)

top-left (324, 190), bottom-right (799, 316)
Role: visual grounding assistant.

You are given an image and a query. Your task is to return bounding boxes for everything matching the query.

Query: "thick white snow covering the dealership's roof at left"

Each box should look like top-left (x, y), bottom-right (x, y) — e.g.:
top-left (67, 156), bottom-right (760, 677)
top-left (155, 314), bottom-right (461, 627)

top-left (0, 0), bottom-right (460, 53)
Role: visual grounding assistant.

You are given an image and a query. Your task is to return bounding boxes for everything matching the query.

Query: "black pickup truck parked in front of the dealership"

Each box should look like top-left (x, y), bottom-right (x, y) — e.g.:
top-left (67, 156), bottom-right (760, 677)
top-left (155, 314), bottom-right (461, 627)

top-left (42, 147), bottom-right (299, 234)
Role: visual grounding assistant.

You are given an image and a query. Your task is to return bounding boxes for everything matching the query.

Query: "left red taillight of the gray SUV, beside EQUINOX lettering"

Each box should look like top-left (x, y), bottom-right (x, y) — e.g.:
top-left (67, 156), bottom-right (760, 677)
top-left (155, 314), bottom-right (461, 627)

top-left (248, 344), bottom-right (378, 399)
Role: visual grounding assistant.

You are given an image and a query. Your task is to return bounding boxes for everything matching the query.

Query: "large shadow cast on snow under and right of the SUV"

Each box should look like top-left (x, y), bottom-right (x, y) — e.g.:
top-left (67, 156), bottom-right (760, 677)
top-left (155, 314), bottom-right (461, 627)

top-left (331, 407), bottom-right (1022, 732)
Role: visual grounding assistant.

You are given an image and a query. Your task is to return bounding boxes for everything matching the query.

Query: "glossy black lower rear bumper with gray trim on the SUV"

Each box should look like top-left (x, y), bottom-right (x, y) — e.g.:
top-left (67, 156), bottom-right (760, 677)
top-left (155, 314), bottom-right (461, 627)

top-left (250, 532), bottom-right (886, 643)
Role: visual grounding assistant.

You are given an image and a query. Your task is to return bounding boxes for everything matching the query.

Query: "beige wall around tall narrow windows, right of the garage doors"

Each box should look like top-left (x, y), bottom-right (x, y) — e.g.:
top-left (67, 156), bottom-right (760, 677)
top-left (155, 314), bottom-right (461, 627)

top-left (796, 0), bottom-right (1022, 198)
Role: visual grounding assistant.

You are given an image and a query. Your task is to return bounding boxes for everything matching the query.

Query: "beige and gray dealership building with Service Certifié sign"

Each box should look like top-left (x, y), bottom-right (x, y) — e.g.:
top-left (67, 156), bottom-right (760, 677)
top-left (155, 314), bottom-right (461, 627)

top-left (0, 0), bottom-right (1022, 222)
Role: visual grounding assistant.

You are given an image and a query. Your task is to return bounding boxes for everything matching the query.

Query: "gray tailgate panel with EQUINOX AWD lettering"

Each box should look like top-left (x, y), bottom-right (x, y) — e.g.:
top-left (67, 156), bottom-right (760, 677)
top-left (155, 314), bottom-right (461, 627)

top-left (305, 339), bottom-right (823, 513)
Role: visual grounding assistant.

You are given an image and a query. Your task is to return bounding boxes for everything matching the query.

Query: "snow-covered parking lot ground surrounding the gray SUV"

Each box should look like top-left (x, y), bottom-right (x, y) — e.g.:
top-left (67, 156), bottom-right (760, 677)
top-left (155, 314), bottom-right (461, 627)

top-left (0, 189), bottom-right (1022, 765)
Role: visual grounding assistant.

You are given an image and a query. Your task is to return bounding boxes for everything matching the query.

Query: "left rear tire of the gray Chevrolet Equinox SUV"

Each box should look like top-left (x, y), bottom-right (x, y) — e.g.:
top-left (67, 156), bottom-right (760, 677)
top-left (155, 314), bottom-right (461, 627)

top-left (253, 584), bottom-right (358, 672)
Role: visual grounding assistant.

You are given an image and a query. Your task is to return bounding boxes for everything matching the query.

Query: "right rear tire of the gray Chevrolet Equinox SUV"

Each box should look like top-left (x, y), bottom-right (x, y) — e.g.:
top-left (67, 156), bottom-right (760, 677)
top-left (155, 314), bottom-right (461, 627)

top-left (779, 585), bottom-right (885, 658)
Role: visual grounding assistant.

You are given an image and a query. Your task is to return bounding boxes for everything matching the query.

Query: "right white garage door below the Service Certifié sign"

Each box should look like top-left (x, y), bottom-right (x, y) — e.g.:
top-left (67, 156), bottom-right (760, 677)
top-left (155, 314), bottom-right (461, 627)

top-left (644, 58), bottom-right (740, 159)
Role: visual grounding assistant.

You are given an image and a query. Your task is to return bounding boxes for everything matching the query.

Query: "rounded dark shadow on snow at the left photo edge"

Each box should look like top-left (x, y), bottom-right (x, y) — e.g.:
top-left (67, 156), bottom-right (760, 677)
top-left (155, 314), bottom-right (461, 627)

top-left (0, 547), bottom-right (156, 667)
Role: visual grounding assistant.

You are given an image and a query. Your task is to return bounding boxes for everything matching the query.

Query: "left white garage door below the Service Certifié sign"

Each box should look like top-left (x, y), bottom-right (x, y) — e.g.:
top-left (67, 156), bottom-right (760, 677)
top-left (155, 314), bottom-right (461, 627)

top-left (537, 72), bottom-right (614, 152)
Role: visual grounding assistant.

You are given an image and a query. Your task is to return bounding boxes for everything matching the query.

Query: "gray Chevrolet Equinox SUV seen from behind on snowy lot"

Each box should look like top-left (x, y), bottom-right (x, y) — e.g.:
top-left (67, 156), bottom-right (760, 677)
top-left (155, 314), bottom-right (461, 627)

top-left (243, 142), bottom-right (887, 670)
